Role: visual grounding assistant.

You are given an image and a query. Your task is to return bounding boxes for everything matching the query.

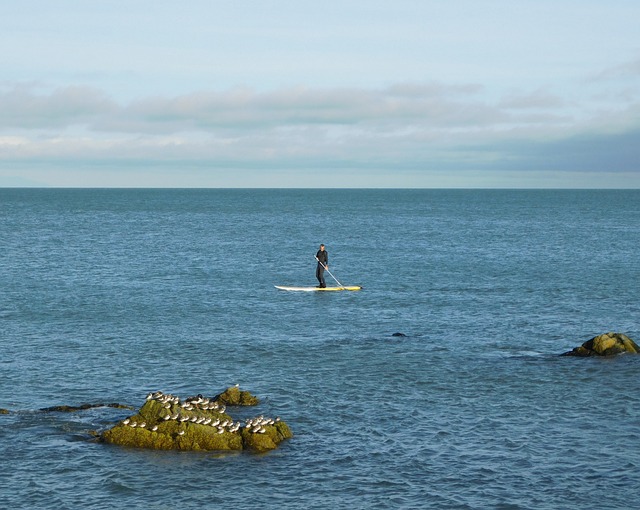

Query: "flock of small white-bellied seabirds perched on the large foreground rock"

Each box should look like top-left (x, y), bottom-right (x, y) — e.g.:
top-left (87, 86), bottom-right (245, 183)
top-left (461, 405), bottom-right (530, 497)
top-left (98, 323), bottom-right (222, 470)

top-left (122, 391), bottom-right (280, 436)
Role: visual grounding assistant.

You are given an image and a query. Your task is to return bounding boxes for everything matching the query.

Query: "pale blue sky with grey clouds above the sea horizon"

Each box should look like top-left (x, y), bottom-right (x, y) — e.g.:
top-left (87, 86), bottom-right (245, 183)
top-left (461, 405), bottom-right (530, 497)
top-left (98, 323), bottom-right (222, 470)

top-left (0, 0), bottom-right (640, 188)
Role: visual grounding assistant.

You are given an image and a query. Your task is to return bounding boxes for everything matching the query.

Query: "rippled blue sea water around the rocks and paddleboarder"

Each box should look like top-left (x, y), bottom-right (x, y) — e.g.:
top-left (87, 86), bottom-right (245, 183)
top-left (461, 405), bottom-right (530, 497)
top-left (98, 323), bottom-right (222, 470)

top-left (0, 189), bottom-right (640, 509)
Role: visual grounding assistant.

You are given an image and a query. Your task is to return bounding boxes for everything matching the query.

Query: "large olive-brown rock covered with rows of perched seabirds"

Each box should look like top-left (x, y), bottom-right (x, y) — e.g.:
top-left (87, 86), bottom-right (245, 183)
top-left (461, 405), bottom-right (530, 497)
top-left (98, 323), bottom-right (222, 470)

top-left (101, 388), bottom-right (293, 452)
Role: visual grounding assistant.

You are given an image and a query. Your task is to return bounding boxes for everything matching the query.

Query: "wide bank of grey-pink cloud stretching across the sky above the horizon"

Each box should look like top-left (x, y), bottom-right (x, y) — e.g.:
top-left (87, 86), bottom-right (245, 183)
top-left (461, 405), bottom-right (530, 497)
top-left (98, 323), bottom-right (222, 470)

top-left (0, 82), bottom-right (640, 181)
